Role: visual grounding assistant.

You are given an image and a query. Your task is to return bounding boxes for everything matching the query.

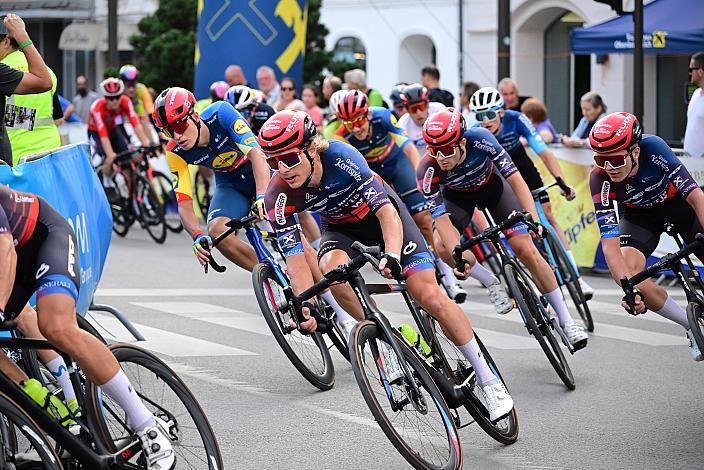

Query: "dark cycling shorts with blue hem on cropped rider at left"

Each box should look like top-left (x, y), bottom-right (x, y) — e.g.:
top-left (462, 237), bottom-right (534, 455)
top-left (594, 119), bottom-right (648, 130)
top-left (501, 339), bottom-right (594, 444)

top-left (5, 198), bottom-right (80, 319)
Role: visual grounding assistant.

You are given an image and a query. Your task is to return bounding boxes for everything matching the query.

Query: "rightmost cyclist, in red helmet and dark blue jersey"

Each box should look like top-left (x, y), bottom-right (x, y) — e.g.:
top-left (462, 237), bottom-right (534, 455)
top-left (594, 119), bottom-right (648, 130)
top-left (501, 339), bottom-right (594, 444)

top-left (589, 113), bottom-right (704, 361)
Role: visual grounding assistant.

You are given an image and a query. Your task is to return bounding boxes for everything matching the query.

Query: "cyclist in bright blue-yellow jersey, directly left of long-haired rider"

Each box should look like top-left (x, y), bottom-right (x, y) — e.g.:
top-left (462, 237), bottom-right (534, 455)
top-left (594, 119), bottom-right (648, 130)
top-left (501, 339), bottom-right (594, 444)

top-left (152, 87), bottom-right (269, 271)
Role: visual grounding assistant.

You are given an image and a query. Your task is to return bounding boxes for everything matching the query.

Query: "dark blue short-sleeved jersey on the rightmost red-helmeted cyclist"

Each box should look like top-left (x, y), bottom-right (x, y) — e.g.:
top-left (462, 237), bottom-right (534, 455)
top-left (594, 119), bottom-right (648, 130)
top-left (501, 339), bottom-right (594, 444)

top-left (589, 135), bottom-right (698, 238)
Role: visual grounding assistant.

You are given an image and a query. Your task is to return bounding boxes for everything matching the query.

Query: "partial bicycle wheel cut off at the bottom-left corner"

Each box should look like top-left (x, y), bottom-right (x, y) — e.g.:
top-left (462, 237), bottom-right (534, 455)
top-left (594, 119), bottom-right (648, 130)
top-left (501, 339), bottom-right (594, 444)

top-left (0, 393), bottom-right (63, 470)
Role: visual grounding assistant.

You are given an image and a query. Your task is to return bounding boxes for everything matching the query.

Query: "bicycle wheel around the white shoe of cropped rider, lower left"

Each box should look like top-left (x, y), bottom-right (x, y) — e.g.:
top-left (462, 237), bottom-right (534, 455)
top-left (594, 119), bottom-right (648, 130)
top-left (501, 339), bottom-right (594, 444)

top-left (86, 344), bottom-right (224, 470)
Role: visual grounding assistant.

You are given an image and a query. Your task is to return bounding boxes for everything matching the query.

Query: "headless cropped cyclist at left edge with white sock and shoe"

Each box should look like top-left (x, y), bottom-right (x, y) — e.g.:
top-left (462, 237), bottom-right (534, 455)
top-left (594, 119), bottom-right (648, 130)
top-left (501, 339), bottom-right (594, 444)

top-left (0, 185), bottom-right (176, 470)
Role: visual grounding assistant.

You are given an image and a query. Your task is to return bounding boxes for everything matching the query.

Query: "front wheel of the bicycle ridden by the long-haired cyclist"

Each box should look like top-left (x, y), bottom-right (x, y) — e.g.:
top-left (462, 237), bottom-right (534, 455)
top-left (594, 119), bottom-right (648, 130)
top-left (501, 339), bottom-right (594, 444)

top-left (350, 321), bottom-right (462, 470)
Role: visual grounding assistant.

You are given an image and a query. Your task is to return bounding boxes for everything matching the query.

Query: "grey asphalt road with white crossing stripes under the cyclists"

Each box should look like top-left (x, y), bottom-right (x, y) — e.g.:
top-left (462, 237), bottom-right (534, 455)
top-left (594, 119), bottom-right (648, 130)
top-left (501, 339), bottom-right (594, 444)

top-left (93, 228), bottom-right (704, 469)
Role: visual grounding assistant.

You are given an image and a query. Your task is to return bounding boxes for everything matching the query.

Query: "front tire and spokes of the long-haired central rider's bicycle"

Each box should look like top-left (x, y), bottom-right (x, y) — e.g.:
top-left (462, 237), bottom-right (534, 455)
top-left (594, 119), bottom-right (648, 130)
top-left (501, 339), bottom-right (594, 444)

top-left (350, 320), bottom-right (462, 470)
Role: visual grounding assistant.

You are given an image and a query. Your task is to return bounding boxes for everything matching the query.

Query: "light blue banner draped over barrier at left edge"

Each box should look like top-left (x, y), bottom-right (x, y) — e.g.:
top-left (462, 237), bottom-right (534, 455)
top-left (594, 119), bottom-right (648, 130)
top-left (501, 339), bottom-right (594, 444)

top-left (0, 144), bottom-right (112, 315)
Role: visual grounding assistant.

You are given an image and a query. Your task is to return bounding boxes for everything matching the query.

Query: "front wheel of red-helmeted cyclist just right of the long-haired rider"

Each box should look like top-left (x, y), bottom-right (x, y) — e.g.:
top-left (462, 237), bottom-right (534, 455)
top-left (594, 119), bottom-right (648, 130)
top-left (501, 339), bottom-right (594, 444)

top-left (504, 263), bottom-right (575, 390)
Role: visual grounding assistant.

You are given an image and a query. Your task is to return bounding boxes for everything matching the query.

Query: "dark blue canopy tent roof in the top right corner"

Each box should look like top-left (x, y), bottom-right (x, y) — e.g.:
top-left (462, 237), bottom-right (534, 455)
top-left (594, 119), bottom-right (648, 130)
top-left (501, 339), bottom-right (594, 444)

top-left (572, 0), bottom-right (704, 55)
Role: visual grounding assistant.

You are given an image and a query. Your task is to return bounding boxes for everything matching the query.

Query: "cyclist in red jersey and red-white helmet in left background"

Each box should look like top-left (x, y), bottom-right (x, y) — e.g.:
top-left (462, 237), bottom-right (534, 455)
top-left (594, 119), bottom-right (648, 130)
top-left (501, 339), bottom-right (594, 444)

top-left (88, 78), bottom-right (149, 198)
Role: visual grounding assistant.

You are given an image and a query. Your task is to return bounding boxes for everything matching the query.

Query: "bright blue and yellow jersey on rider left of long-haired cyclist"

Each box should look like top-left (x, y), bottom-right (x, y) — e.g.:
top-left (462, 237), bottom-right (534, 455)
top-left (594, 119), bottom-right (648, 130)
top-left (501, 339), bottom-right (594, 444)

top-left (166, 101), bottom-right (259, 202)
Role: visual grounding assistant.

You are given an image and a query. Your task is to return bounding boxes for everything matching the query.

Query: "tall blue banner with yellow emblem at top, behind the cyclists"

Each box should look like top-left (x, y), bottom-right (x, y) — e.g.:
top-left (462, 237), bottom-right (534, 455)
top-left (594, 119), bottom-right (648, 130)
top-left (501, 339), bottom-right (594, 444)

top-left (194, 0), bottom-right (308, 99)
